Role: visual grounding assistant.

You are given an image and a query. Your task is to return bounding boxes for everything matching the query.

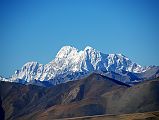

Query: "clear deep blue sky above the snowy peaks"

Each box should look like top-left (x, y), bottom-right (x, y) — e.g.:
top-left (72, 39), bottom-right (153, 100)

top-left (0, 0), bottom-right (159, 77)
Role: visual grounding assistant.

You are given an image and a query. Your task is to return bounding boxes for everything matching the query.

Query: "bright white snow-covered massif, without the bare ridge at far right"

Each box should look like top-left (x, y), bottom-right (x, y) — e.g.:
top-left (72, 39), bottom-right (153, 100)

top-left (1, 46), bottom-right (157, 84)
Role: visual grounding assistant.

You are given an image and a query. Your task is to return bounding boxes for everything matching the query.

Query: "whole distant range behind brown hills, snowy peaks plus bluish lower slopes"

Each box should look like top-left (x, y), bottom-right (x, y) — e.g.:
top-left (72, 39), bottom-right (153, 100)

top-left (0, 46), bottom-right (159, 86)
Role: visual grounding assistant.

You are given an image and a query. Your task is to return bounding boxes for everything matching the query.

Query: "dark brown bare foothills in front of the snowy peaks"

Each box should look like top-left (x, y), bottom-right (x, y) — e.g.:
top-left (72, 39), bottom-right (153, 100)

top-left (0, 73), bottom-right (159, 120)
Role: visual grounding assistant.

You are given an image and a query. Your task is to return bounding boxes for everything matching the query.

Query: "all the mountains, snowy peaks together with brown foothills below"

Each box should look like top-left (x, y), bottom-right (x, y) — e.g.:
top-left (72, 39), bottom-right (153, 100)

top-left (0, 46), bottom-right (159, 120)
